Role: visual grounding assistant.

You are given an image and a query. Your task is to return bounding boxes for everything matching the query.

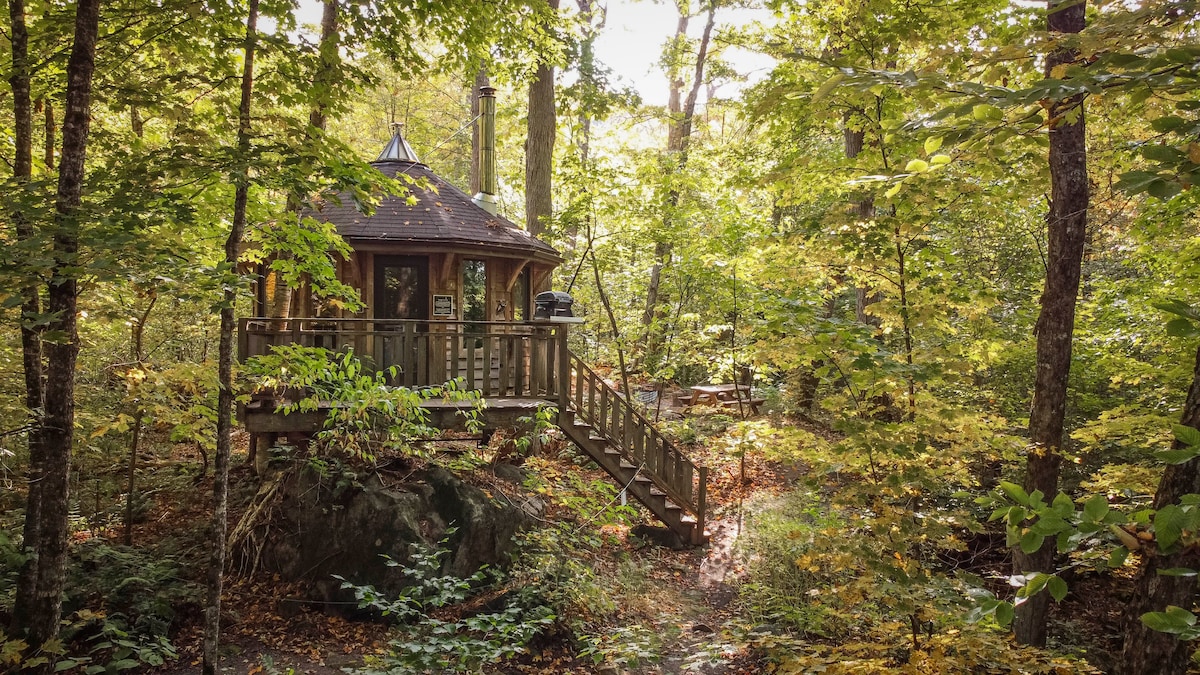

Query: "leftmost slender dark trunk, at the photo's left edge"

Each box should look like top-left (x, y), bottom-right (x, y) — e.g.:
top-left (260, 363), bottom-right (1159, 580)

top-left (8, 0), bottom-right (46, 635)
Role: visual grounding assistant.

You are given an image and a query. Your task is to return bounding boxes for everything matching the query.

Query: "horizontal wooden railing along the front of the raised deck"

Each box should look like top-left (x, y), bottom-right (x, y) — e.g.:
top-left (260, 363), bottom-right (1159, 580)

top-left (238, 317), bottom-right (566, 400)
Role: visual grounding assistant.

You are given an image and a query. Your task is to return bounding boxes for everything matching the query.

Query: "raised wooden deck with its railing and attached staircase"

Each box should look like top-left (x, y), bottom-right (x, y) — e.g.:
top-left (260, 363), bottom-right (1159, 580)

top-left (238, 318), bottom-right (708, 544)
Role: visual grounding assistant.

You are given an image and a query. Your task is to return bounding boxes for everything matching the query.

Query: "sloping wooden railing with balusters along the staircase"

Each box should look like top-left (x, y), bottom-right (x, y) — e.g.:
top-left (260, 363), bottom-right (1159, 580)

top-left (559, 351), bottom-right (708, 523)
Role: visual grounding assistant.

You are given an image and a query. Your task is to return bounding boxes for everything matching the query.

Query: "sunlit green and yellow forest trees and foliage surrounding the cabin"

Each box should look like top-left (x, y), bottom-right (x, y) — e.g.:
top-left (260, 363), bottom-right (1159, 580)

top-left (0, 0), bottom-right (1200, 675)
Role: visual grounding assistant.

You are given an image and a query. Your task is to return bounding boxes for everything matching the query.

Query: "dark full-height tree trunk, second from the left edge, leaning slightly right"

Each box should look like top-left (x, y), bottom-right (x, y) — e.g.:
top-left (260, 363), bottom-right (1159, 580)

top-left (26, 0), bottom-right (100, 645)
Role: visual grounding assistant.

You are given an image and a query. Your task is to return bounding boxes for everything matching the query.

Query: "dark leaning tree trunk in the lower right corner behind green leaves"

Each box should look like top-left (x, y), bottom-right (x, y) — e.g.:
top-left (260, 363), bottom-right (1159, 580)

top-left (1117, 348), bottom-right (1200, 675)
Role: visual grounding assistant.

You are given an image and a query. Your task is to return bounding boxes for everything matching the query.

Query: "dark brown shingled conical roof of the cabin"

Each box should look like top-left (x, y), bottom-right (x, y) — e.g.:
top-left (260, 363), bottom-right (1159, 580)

top-left (313, 156), bottom-right (563, 264)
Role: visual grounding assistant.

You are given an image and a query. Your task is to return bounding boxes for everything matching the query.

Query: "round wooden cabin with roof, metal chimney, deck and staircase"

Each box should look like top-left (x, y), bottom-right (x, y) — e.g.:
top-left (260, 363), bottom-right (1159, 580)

top-left (238, 88), bottom-right (707, 544)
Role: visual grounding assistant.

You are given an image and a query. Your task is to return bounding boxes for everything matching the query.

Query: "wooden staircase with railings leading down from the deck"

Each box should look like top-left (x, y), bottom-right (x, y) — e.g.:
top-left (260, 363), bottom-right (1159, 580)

top-left (558, 350), bottom-right (708, 545)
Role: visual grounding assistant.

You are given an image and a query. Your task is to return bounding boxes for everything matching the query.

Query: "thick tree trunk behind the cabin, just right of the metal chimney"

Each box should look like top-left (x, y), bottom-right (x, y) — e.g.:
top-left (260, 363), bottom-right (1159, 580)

top-left (526, 0), bottom-right (558, 237)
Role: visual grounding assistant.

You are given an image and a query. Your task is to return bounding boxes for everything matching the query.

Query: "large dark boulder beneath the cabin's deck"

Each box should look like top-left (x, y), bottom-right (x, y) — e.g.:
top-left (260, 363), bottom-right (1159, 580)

top-left (259, 467), bottom-right (528, 609)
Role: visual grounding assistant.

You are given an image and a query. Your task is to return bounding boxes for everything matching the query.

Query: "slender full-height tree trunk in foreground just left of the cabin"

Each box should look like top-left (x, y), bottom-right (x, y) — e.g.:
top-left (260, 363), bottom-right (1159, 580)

top-left (202, 0), bottom-right (258, 675)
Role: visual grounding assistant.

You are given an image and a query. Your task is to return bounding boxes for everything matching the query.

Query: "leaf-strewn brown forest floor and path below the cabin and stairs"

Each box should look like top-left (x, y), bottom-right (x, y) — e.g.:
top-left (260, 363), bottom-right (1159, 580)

top-left (156, 408), bottom-right (799, 675)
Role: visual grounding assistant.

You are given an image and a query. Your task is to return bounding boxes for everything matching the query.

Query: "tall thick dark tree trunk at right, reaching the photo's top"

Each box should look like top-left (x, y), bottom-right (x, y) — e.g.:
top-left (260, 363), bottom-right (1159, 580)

top-left (1013, 0), bottom-right (1088, 646)
